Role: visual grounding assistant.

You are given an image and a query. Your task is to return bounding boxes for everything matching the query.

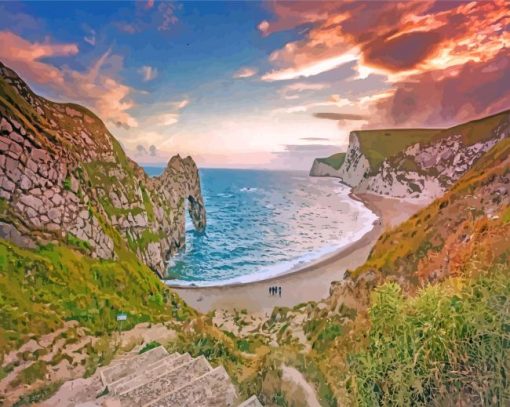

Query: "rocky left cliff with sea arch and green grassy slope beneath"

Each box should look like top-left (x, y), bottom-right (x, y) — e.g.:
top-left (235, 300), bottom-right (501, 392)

top-left (0, 63), bottom-right (205, 404)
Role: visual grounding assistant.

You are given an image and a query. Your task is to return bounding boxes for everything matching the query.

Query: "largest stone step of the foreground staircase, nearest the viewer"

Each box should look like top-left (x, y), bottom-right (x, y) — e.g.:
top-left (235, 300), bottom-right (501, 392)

top-left (145, 366), bottom-right (236, 407)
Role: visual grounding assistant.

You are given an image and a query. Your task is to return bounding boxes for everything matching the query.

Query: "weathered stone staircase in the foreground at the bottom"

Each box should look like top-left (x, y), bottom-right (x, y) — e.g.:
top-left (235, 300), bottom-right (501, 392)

top-left (91, 346), bottom-right (261, 407)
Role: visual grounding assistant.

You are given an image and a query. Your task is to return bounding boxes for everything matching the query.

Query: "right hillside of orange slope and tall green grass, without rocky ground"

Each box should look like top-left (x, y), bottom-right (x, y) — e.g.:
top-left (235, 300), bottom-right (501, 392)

top-left (311, 140), bottom-right (510, 406)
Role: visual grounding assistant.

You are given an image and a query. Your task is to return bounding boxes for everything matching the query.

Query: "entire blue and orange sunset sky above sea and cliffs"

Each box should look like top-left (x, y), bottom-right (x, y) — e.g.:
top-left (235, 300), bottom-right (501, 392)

top-left (0, 0), bottom-right (510, 169)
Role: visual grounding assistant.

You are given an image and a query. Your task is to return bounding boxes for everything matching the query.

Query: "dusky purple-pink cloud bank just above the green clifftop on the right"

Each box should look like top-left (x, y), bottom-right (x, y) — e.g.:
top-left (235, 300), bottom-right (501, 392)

top-left (371, 49), bottom-right (510, 127)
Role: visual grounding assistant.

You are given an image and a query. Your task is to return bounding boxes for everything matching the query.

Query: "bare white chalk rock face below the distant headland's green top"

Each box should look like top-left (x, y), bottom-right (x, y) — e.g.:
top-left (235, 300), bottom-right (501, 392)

top-left (330, 113), bottom-right (510, 203)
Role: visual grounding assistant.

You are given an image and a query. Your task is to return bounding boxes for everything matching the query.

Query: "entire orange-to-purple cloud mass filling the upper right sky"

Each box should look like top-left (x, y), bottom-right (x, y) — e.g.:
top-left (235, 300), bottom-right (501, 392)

top-left (259, 0), bottom-right (510, 125)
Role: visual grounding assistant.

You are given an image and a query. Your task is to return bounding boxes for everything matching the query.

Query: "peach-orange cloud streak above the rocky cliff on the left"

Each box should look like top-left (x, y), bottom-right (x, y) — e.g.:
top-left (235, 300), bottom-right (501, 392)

top-left (0, 31), bottom-right (138, 127)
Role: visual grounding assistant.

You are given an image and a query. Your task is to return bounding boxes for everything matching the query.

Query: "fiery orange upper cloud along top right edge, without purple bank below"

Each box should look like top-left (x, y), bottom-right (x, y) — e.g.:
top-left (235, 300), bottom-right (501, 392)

top-left (264, 0), bottom-right (510, 79)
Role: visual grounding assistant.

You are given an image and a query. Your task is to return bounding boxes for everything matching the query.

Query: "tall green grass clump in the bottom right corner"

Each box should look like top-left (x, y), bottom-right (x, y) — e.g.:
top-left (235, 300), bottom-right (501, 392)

top-left (350, 270), bottom-right (510, 406)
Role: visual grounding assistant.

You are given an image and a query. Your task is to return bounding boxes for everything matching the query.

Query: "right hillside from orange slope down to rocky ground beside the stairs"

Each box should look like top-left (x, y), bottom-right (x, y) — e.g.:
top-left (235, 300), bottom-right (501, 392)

top-left (138, 129), bottom-right (510, 406)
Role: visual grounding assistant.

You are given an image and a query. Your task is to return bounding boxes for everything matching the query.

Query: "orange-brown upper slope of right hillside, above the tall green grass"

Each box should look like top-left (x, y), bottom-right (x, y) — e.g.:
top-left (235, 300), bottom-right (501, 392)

top-left (353, 139), bottom-right (510, 281)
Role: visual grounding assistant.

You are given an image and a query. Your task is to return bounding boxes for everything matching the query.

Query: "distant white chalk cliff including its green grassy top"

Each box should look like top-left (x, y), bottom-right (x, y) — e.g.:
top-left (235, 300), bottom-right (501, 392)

top-left (316, 111), bottom-right (510, 202)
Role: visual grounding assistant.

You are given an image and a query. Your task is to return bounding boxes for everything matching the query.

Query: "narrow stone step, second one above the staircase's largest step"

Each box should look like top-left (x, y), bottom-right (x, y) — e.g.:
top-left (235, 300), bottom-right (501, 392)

top-left (109, 353), bottom-right (192, 394)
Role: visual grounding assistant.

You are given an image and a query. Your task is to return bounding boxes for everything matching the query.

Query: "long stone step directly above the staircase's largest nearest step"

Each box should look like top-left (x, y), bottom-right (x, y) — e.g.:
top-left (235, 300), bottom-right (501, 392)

top-left (120, 356), bottom-right (212, 406)
